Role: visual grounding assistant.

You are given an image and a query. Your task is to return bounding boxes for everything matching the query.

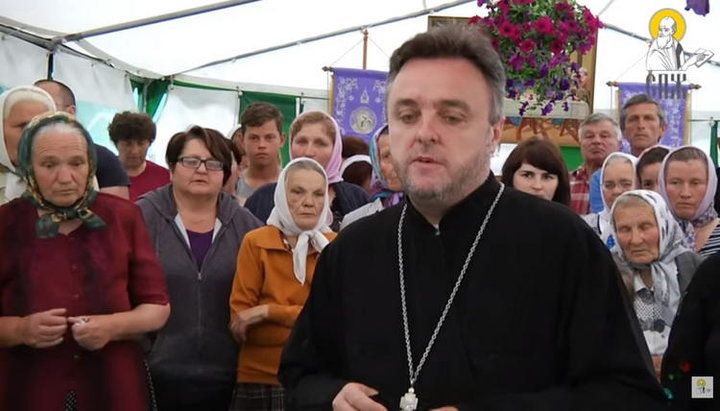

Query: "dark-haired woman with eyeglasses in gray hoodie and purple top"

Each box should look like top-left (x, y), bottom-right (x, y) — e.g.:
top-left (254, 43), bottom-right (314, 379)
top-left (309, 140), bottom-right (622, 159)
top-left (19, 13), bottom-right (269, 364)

top-left (138, 126), bottom-right (261, 411)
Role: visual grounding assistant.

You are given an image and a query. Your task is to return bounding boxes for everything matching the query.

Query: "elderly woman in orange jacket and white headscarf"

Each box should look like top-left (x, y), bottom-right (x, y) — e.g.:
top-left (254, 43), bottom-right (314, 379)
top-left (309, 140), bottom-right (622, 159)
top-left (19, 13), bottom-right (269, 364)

top-left (230, 157), bottom-right (335, 410)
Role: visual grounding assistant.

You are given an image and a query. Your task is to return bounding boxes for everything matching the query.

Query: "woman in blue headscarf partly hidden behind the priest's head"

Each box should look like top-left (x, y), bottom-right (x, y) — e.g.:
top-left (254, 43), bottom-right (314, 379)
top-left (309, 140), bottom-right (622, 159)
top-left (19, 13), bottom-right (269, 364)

top-left (340, 125), bottom-right (404, 230)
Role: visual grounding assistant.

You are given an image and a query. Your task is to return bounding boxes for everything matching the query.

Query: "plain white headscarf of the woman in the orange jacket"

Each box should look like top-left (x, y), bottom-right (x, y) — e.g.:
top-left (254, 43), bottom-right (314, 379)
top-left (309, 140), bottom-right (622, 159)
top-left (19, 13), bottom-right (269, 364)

top-left (267, 157), bottom-right (332, 284)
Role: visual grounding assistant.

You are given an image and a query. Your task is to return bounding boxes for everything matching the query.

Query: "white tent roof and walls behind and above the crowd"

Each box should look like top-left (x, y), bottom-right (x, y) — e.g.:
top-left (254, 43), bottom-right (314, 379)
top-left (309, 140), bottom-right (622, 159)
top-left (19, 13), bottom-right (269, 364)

top-left (0, 0), bottom-right (720, 167)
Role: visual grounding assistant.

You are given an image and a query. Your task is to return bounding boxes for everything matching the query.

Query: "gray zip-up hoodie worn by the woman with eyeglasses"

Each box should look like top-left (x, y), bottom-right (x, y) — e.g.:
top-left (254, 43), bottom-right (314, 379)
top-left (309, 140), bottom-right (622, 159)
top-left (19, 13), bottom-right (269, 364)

top-left (137, 185), bottom-right (262, 386)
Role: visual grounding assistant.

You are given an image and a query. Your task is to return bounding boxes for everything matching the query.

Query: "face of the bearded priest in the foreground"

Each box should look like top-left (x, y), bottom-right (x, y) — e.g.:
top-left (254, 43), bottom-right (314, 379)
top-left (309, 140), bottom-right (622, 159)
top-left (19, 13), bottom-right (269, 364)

top-left (388, 58), bottom-right (502, 207)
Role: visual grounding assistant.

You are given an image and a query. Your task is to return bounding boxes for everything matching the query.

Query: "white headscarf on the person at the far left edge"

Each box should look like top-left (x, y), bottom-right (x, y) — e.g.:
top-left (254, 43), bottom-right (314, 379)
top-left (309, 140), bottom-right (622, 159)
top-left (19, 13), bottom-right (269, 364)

top-left (0, 86), bottom-right (56, 204)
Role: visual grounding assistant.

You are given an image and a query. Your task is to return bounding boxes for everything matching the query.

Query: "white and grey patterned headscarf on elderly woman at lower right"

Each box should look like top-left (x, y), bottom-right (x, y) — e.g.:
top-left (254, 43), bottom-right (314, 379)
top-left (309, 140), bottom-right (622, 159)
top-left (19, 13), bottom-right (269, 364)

top-left (611, 190), bottom-right (692, 325)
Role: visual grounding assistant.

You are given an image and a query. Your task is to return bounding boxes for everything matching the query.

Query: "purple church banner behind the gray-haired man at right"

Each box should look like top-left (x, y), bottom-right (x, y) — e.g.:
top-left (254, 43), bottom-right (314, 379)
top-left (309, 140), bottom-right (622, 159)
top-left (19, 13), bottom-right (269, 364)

top-left (619, 83), bottom-right (688, 151)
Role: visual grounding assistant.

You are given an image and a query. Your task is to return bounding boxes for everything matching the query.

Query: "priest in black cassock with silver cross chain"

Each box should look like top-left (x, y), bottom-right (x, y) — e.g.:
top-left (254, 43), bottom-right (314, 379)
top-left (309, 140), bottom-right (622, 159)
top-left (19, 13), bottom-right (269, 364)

top-left (280, 27), bottom-right (665, 411)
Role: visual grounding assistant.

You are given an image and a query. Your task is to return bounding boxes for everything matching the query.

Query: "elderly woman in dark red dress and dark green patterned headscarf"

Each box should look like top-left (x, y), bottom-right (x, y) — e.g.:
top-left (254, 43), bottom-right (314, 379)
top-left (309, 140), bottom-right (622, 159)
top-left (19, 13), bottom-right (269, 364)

top-left (0, 113), bottom-right (170, 411)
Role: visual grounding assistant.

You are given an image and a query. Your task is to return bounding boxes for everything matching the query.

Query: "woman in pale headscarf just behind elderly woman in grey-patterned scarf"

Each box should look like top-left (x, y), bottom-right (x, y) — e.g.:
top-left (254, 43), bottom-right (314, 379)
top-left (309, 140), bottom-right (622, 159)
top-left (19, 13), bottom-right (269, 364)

top-left (582, 152), bottom-right (637, 248)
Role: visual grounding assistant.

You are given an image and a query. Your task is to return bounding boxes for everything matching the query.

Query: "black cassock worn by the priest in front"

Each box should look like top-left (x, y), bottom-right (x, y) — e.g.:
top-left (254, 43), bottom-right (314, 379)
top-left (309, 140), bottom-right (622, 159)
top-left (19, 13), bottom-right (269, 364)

top-left (280, 175), bottom-right (664, 411)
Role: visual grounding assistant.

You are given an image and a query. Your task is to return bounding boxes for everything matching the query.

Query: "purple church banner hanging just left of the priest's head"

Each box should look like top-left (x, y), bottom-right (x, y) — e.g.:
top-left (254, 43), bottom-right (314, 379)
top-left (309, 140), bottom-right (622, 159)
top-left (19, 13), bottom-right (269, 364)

top-left (332, 68), bottom-right (387, 142)
